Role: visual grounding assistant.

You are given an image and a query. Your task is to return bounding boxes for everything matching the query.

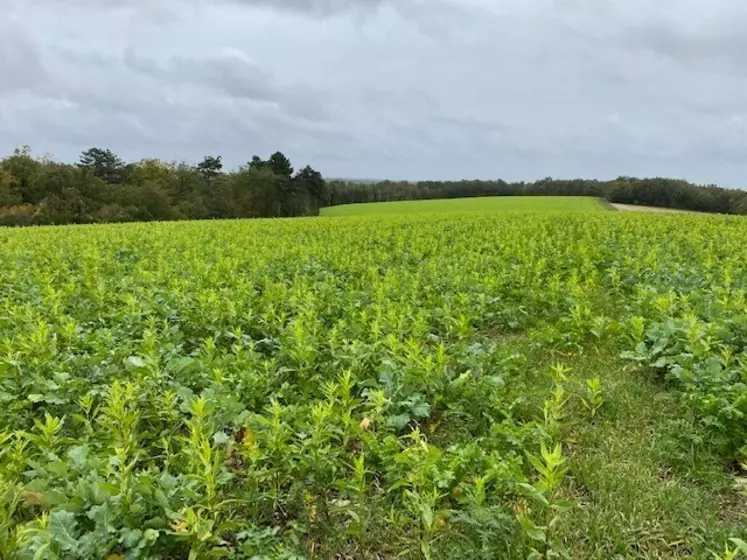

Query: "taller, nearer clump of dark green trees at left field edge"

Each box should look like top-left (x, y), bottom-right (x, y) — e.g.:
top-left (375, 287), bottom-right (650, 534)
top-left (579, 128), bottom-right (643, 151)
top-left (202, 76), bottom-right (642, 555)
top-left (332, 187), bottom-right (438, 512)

top-left (0, 148), bottom-right (329, 226)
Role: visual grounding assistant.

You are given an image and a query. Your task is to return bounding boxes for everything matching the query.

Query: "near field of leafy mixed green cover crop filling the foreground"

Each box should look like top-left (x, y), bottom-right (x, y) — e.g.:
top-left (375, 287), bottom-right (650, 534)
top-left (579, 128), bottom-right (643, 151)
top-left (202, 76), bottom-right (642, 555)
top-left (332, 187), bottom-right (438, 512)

top-left (0, 208), bottom-right (747, 560)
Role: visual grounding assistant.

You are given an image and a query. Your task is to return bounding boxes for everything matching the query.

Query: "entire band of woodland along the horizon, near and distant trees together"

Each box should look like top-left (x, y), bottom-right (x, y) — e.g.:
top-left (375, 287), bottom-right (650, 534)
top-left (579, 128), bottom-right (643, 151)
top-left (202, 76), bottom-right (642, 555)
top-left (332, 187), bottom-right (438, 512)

top-left (0, 148), bottom-right (747, 226)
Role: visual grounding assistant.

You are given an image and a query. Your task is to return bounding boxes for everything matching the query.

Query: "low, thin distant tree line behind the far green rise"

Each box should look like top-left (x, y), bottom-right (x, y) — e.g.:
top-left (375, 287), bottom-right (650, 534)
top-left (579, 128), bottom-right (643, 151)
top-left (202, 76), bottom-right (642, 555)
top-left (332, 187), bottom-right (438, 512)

top-left (327, 177), bottom-right (747, 214)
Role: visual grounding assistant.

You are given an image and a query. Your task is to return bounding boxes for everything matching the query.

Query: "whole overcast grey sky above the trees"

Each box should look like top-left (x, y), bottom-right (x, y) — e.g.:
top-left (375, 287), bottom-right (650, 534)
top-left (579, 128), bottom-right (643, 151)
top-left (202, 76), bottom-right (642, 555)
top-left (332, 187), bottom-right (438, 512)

top-left (0, 0), bottom-right (747, 187)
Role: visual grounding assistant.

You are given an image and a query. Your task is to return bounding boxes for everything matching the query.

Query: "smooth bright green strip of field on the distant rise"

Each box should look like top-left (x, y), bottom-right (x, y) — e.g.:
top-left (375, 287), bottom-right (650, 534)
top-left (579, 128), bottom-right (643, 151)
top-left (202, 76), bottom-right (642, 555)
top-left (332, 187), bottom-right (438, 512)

top-left (322, 196), bottom-right (604, 216)
